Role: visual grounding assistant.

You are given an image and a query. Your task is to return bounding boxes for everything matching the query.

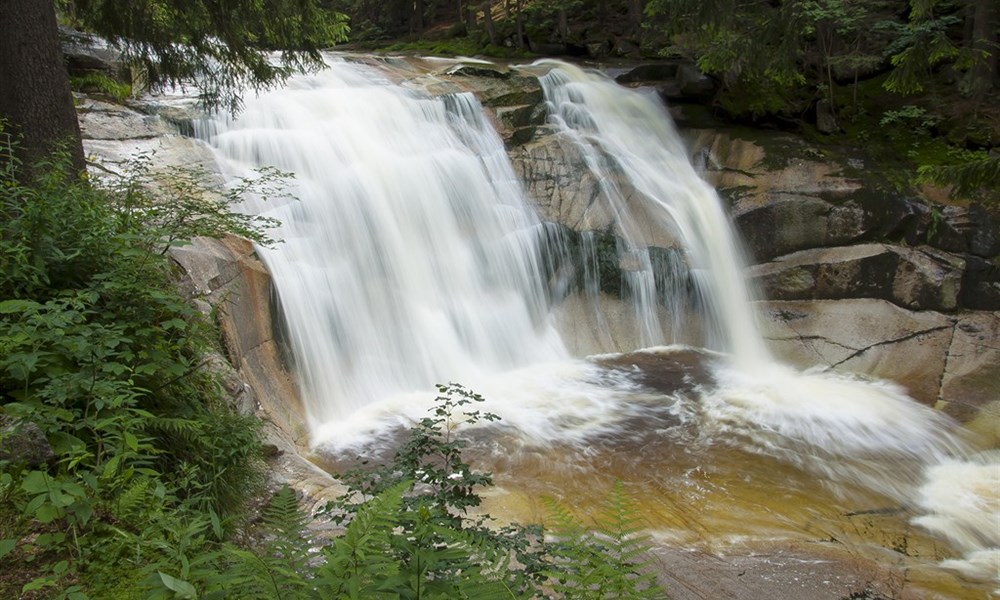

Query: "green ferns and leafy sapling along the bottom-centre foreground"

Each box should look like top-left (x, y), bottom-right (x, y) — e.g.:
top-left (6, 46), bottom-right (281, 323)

top-left (143, 384), bottom-right (667, 600)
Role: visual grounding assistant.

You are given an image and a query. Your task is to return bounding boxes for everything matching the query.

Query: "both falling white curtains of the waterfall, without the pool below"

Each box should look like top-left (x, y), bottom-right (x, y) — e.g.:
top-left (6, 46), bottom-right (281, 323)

top-left (200, 59), bottom-right (767, 434)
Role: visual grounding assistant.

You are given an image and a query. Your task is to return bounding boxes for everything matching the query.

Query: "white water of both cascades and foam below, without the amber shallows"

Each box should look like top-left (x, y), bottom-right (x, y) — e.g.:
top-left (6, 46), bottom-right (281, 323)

top-left (191, 54), bottom-right (1000, 588)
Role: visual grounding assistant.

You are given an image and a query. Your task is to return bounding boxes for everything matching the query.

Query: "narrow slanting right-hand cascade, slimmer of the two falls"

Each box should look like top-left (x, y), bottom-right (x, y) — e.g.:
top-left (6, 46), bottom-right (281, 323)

top-left (536, 61), bottom-right (768, 367)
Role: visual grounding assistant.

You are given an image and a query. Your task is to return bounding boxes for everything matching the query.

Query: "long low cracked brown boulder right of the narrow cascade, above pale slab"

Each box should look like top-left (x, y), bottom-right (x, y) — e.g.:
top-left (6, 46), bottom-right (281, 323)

top-left (747, 244), bottom-right (965, 311)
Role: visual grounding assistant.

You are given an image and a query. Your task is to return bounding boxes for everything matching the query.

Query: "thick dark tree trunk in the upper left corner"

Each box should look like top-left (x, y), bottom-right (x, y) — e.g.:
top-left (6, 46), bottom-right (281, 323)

top-left (0, 0), bottom-right (86, 173)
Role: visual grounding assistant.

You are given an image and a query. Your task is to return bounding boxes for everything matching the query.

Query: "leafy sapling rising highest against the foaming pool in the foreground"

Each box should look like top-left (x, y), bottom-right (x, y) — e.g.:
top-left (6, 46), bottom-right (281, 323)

top-left (327, 383), bottom-right (542, 598)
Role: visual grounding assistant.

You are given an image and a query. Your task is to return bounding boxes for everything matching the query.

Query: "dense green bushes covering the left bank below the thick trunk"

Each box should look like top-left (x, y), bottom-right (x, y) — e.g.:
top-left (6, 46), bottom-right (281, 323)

top-left (0, 129), bottom-right (267, 599)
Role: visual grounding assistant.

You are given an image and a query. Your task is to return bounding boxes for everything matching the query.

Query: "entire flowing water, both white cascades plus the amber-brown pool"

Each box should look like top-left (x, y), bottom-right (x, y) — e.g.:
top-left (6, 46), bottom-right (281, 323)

top-left (191, 57), bottom-right (1000, 597)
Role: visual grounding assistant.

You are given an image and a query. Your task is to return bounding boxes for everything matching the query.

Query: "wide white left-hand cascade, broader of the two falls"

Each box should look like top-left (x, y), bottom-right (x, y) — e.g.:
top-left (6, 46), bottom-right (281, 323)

top-left (202, 60), bottom-right (565, 429)
